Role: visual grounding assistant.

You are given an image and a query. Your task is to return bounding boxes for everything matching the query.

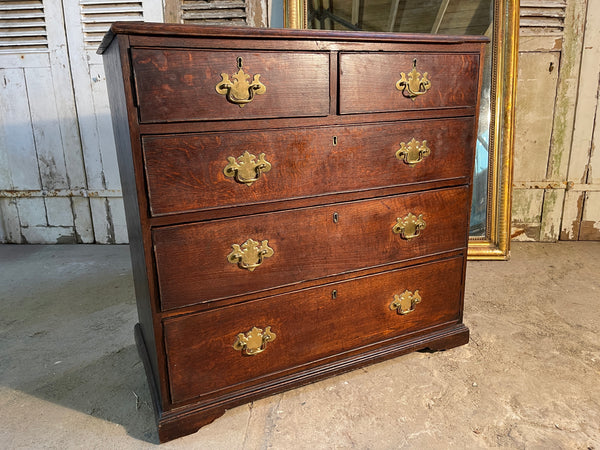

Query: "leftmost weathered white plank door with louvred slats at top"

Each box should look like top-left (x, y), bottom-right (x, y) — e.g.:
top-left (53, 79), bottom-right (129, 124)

top-left (0, 0), bottom-right (93, 243)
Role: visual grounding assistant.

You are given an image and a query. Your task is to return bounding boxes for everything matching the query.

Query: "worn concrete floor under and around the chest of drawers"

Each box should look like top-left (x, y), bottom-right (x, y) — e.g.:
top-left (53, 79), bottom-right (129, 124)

top-left (0, 243), bottom-right (600, 450)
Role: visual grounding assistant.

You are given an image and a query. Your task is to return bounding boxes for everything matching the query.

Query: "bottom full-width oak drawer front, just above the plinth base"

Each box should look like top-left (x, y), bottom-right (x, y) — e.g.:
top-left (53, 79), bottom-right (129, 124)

top-left (164, 258), bottom-right (463, 403)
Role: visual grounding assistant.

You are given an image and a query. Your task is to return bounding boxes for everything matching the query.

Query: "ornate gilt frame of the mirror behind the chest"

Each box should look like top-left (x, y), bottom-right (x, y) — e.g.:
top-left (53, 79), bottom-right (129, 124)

top-left (284, 0), bottom-right (519, 260)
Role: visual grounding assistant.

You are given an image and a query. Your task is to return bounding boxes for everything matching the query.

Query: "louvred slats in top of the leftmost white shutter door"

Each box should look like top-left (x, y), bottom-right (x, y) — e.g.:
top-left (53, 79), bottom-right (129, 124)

top-left (0, 0), bottom-right (48, 53)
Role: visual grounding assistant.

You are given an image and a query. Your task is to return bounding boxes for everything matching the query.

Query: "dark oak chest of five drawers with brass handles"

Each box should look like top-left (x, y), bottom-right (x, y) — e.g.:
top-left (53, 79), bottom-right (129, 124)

top-left (99, 23), bottom-right (485, 441)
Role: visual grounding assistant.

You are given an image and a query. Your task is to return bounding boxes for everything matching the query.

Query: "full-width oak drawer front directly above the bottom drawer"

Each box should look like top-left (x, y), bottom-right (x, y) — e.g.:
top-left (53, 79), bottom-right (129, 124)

top-left (153, 187), bottom-right (469, 310)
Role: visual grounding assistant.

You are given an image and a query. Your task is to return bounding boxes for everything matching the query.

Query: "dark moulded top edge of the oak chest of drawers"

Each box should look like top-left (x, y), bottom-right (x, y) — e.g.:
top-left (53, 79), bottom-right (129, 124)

top-left (97, 22), bottom-right (489, 54)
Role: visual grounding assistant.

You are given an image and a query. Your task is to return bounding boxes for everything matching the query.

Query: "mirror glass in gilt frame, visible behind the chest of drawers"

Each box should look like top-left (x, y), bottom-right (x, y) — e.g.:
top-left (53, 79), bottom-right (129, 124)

top-left (306, 0), bottom-right (494, 238)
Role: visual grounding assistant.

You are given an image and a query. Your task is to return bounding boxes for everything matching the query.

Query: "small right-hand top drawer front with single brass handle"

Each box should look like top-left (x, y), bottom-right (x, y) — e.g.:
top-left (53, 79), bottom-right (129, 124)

top-left (340, 53), bottom-right (479, 114)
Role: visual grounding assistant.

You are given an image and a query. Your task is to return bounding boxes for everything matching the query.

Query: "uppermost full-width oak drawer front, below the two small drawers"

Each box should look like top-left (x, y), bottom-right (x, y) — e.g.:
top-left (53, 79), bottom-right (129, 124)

top-left (143, 117), bottom-right (474, 215)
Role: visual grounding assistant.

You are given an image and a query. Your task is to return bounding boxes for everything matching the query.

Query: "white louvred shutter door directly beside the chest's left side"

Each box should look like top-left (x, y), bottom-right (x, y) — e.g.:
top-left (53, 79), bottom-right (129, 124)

top-left (63, 0), bottom-right (163, 243)
